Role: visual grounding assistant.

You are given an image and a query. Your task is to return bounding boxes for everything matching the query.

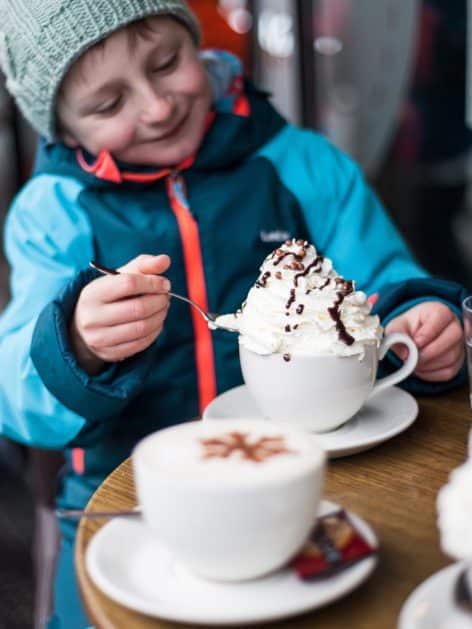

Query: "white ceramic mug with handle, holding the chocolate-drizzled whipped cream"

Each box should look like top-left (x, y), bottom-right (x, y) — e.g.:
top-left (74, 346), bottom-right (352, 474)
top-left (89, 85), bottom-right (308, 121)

top-left (239, 332), bottom-right (418, 432)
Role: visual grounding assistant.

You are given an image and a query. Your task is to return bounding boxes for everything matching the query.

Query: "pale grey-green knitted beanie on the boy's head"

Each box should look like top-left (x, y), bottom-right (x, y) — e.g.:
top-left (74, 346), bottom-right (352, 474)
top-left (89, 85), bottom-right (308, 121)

top-left (0, 0), bottom-right (200, 140)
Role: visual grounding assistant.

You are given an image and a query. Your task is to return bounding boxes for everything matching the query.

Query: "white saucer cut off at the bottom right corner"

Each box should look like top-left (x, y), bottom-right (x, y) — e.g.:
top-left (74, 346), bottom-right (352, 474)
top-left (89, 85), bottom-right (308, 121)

top-left (398, 562), bottom-right (472, 629)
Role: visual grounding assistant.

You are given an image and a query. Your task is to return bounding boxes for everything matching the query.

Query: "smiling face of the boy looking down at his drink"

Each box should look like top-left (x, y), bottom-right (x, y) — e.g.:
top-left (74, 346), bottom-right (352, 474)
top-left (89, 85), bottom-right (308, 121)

top-left (57, 16), bottom-right (211, 166)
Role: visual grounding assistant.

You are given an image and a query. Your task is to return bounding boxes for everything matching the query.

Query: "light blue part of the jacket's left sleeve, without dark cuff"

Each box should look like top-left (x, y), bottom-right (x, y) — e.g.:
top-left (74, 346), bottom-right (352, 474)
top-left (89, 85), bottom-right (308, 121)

top-left (0, 176), bottom-right (92, 448)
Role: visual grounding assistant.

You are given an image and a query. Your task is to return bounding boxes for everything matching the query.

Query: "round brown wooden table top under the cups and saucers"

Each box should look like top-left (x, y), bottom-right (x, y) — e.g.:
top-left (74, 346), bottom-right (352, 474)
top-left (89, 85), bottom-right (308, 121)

top-left (76, 389), bottom-right (472, 629)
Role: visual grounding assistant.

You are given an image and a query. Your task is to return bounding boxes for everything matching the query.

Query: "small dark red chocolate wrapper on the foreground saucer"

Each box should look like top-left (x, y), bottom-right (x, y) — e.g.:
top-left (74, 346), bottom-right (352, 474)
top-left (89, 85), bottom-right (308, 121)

top-left (292, 509), bottom-right (377, 580)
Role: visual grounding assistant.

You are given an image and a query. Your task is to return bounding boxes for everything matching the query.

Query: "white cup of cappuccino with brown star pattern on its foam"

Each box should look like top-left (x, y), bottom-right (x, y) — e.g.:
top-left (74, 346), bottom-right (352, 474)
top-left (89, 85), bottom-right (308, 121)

top-left (132, 419), bottom-right (325, 581)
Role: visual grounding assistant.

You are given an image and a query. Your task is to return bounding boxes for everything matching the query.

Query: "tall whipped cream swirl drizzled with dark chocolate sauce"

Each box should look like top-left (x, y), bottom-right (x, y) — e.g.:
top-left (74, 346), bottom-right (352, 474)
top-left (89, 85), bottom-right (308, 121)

top-left (217, 239), bottom-right (382, 360)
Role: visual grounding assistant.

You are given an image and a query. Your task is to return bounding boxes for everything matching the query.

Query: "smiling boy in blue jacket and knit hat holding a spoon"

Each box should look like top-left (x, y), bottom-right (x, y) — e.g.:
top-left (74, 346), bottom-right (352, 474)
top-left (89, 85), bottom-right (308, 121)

top-left (0, 0), bottom-right (464, 629)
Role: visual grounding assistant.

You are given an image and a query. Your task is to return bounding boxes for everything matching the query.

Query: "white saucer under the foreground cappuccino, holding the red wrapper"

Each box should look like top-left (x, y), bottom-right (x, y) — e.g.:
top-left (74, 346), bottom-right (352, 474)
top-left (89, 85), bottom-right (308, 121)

top-left (86, 501), bottom-right (377, 626)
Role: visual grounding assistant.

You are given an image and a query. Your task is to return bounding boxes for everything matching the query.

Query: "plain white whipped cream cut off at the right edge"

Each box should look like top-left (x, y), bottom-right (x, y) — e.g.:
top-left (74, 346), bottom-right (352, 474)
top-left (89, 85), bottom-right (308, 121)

top-left (437, 459), bottom-right (472, 561)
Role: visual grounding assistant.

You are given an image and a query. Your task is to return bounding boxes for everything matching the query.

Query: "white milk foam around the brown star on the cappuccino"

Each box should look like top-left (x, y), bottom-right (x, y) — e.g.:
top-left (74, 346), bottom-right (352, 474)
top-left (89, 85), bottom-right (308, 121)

top-left (136, 420), bottom-right (324, 486)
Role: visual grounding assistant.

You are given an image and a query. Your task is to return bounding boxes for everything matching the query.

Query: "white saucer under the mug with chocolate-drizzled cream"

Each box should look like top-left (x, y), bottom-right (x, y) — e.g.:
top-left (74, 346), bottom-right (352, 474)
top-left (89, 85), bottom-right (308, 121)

top-left (203, 385), bottom-right (418, 458)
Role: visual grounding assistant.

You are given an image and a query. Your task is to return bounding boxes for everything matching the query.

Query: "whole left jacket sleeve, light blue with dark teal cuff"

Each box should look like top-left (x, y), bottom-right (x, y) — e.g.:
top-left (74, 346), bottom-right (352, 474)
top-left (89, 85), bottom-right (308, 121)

top-left (0, 175), bottom-right (159, 448)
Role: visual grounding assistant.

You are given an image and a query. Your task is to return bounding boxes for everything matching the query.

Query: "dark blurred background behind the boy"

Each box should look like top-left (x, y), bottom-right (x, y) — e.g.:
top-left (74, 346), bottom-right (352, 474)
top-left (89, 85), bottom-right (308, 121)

top-left (0, 0), bottom-right (472, 629)
